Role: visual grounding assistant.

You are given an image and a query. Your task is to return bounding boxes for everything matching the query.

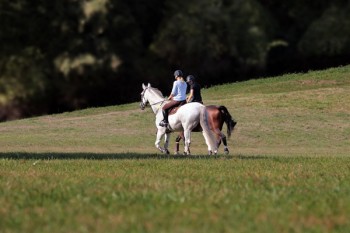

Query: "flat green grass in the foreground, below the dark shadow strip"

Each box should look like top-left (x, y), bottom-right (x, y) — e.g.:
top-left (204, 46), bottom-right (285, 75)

top-left (0, 155), bottom-right (350, 232)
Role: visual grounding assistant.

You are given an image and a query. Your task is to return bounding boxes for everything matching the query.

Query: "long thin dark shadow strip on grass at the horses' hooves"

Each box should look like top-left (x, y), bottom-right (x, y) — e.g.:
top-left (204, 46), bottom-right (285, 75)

top-left (0, 152), bottom-right (269, 160)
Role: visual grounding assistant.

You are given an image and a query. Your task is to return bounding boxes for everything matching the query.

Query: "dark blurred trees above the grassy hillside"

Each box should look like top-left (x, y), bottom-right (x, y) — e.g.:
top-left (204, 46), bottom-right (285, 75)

top-left (0, 0), bottom-right (350, 120)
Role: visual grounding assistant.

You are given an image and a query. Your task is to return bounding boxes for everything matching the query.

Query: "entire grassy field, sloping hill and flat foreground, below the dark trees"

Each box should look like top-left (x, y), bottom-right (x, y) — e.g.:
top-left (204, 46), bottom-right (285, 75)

top-left (0, 66), bottom-right (350, 233)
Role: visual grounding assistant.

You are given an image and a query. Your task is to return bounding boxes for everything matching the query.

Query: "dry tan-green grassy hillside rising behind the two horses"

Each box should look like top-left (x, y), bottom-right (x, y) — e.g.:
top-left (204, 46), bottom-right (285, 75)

top-left (0, 66), bottom-right (350, 155)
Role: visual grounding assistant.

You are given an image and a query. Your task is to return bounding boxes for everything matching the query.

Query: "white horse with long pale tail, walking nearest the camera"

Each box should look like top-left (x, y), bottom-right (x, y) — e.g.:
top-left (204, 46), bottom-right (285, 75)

top-left (140, 84), bottom-right (217, 155)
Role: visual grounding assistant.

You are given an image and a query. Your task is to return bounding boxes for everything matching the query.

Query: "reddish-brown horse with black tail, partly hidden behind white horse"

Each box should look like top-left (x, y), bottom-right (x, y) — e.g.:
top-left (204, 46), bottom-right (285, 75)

top-left (175, 105), bottom-right (237, 154)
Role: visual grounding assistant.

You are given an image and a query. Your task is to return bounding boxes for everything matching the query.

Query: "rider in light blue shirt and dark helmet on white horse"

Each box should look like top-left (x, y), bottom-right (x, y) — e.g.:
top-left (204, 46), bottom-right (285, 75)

top-left (159, 70), bottom-right (187, 127)
